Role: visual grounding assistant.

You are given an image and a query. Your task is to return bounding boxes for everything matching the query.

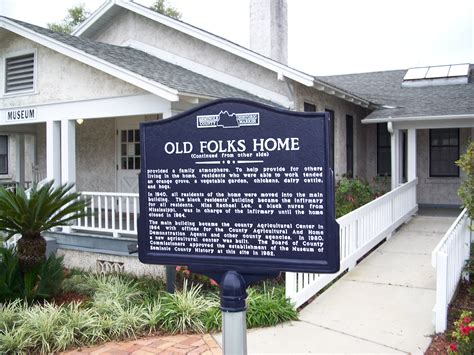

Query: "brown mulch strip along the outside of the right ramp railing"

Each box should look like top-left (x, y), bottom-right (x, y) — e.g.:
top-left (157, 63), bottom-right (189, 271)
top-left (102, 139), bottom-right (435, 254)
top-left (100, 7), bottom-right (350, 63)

top-left (425, 280), bottom-right (474, 355)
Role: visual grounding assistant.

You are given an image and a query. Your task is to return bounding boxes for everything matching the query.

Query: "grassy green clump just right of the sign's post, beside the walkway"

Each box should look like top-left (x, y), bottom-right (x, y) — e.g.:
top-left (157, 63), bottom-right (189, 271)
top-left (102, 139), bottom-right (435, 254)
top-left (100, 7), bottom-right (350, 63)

top-left (247, 286), bottom-right (298, 328)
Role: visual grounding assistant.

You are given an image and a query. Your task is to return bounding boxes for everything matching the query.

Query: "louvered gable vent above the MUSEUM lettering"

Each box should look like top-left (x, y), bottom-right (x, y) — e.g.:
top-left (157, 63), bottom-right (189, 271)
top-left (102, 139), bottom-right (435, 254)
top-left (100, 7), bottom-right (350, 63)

top-left (5, 53), bottom-right (35, 94)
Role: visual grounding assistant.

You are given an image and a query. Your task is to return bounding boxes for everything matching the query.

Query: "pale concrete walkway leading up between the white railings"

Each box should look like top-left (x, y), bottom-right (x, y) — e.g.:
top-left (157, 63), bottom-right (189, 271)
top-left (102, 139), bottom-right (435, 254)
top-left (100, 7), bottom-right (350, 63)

top-left (215, 211), bottom-right (459, 354)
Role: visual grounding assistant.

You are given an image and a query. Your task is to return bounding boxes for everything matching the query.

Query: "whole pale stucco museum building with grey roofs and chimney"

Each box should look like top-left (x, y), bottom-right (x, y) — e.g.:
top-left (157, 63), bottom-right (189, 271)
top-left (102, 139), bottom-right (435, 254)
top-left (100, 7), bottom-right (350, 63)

top-left (0, 0), bottom-right (474, 274)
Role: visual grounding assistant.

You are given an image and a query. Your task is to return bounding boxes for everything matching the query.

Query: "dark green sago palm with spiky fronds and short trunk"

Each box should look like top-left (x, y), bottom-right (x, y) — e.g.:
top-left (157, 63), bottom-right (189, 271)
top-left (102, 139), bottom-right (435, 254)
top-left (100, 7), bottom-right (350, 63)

top-left (0, 181), bottom-right (89, 272)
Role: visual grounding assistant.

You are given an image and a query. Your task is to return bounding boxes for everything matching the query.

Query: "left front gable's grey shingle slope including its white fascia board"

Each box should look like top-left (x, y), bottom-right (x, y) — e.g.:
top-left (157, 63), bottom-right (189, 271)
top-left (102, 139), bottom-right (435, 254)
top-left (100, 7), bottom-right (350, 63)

top-left (0, 17), bottom-right (280, 104)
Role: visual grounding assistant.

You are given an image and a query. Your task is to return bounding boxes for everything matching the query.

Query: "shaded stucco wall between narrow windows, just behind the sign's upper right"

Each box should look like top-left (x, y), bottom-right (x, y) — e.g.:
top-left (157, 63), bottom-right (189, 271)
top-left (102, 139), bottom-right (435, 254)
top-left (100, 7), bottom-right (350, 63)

top-left (295, 85), bottom-right (369, 178)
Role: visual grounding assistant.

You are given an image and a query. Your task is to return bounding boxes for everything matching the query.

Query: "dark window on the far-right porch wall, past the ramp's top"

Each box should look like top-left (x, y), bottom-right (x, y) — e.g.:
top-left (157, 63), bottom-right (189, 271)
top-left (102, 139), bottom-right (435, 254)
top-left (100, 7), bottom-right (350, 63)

top-left (430, 128), bottom-right (459, 177)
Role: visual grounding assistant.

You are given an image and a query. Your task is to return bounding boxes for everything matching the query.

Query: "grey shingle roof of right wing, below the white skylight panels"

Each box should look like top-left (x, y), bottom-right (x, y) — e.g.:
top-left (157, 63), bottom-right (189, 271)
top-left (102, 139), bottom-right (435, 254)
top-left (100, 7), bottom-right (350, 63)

top-left (318, 65), bottom-right (474, 119)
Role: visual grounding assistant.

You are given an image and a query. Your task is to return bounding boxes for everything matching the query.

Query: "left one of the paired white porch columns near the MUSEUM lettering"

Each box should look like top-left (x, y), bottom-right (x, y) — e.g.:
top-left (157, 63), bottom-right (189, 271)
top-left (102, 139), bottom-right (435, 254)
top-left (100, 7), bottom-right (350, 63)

top-left (46, 121), bottom-right (61, 185)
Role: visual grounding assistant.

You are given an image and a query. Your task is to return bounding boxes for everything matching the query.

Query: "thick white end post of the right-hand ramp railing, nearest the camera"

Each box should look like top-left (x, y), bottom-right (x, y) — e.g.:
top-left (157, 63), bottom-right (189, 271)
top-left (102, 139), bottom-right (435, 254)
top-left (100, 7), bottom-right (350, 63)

top-left (435, 252), bottom-right (448, 333)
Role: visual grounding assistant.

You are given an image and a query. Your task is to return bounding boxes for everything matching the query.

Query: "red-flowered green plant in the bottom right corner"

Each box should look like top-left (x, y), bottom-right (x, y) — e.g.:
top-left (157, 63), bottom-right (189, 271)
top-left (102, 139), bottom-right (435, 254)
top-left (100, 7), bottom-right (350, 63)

top-left (447, 311), bottom-right (474, 355)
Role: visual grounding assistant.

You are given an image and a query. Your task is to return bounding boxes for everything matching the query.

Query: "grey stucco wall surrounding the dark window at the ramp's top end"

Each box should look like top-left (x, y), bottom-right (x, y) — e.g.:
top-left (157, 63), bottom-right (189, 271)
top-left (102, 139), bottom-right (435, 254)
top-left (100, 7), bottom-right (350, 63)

top-left (416, 128), bottom-right (474, 205)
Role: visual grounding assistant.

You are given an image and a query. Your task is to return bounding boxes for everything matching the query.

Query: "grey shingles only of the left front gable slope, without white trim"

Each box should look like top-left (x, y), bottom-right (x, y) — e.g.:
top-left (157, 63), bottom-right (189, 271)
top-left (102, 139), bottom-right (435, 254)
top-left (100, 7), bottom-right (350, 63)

top-left (0, 16), bottom-right (278, 106)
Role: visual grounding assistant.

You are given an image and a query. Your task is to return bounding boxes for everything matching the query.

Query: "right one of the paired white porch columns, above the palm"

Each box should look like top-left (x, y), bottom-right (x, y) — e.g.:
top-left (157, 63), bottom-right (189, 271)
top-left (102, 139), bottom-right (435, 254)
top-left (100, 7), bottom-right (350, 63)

top-left (61, 120), bottom-right (76, 184)
